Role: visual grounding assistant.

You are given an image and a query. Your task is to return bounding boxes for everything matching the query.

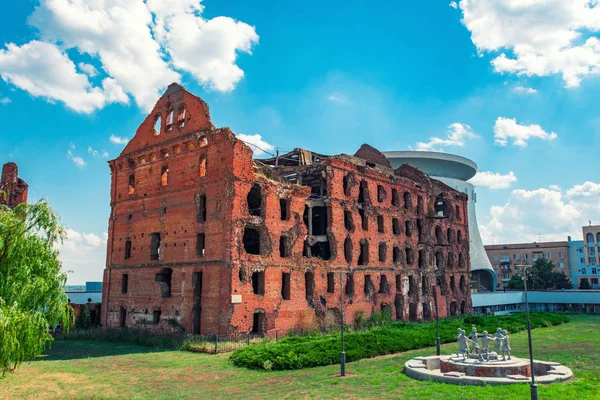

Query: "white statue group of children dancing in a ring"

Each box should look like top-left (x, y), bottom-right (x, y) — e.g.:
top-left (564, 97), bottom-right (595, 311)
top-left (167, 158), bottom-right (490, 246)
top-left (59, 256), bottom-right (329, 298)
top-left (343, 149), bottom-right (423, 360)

top-left (456, 327), bottom-right (511, 361)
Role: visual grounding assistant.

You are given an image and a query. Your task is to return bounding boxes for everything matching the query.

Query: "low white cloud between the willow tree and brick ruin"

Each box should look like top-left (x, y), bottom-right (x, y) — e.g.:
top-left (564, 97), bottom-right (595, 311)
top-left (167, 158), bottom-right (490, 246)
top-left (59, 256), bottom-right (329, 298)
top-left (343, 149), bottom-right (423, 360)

top-left (58, 229), bottom-right (108, 284)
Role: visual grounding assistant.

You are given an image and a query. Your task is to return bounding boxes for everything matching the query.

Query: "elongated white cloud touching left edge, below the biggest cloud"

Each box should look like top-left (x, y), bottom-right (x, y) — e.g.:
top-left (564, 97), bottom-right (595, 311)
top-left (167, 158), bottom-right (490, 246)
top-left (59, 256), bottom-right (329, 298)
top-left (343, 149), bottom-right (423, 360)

top-left (0, 40), bottom-right (127, 113)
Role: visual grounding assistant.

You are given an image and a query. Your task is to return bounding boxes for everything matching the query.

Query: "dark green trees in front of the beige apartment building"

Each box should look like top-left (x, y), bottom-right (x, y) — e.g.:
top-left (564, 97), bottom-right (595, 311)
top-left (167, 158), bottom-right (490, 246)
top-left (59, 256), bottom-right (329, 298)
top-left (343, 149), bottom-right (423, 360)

top-left (507, 258), bottom-right (573, 290)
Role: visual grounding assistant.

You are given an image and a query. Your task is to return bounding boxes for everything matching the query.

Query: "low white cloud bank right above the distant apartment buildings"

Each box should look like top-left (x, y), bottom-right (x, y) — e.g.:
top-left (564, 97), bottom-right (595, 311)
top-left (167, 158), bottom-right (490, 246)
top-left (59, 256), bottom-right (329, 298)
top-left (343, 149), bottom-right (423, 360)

top-left (480, 182), bottom-right (600, 243)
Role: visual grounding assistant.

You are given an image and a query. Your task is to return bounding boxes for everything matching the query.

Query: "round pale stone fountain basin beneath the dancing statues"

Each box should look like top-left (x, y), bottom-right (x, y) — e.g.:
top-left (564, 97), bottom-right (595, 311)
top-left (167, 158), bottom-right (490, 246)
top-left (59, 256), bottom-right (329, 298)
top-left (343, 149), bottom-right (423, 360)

top-left (404, 355), bottom-right (573, 385)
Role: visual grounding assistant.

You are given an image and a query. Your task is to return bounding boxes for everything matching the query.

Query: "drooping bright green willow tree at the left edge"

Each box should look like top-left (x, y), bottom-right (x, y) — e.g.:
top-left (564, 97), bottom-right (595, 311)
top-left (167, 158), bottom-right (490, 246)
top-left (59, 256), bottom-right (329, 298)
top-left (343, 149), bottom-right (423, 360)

top-left (0, 200), bottom-right (72, 374)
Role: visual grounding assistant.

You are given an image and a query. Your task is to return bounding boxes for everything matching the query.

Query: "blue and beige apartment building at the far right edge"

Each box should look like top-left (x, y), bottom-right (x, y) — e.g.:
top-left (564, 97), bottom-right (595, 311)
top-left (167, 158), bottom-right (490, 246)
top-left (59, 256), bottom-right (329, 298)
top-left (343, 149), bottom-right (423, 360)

top-left (568, 225), bottom-right (600, 289)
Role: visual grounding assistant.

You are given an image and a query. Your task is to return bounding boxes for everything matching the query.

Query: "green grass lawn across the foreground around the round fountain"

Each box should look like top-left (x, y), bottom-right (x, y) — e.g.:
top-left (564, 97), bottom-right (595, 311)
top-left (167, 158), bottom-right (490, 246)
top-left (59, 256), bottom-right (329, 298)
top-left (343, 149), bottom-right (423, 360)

top-left (0, 315), bottom-right (600, 400)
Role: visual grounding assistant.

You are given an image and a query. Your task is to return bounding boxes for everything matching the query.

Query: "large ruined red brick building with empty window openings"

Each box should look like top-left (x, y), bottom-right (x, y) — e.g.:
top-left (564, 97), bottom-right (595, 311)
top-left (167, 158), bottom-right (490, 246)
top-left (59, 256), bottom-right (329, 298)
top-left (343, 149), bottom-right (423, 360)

top-left (102, 84), bottom-right (471, 335)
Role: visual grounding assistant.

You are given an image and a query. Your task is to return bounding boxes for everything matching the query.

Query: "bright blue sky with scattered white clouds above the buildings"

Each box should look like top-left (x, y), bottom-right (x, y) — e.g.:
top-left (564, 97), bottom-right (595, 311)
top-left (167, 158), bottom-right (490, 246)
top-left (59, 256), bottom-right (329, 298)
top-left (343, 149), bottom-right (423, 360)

top-left (0, 0), bottom-right (600, 283)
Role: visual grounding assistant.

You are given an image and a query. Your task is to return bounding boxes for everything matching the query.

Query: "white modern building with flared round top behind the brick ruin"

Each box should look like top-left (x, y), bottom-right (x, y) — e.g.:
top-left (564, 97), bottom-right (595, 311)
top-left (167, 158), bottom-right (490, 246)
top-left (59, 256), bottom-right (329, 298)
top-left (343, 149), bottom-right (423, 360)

top-left (383, 151), bottom-right (497, 292)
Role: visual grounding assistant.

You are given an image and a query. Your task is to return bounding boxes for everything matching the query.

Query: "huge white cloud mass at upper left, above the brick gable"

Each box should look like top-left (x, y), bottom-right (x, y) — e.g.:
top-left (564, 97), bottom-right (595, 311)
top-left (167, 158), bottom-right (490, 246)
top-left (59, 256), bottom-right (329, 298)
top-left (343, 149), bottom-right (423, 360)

top-left (0, 0), bottom-right (259, 113)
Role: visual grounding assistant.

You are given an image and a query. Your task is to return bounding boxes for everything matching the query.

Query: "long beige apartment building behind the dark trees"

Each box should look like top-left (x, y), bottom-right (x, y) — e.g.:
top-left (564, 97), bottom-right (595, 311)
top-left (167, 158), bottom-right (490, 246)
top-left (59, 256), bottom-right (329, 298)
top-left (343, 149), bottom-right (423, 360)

top-left (485, 242), bottom-right (568, 290)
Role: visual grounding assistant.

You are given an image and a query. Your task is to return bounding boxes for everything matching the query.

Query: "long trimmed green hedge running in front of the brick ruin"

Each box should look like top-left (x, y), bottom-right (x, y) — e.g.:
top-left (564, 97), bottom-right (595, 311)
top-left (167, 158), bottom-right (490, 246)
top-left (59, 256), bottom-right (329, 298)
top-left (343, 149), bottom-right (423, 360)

top-left (230, 313), bottom-right (568, 370)
